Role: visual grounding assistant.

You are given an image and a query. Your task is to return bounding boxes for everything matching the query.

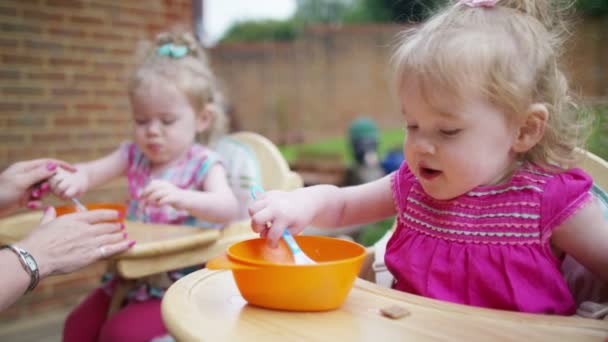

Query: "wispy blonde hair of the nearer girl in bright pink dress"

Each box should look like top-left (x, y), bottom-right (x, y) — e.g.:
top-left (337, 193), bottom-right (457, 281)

top-left (393, 0), bottom-right (590, 168)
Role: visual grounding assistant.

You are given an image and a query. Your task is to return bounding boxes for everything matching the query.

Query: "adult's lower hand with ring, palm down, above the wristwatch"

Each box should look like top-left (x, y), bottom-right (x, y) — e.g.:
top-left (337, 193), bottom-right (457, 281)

top-left (17, 207), bottom-right (135, 277)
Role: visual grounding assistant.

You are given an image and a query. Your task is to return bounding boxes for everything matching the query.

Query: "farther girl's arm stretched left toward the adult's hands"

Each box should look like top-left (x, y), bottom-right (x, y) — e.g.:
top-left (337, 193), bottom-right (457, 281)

top-left (49, 148), bottom-right (127, 199)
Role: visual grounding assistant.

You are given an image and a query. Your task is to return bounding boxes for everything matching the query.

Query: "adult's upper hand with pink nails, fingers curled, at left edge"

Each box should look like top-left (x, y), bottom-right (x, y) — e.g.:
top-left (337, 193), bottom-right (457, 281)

top-left (0, 158), bottom-right (76, 215)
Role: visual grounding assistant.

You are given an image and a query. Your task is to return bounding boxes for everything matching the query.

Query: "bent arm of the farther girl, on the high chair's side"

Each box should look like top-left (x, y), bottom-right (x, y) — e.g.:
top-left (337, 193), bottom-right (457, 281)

top-left (139, 164), bottom-right (238, 223)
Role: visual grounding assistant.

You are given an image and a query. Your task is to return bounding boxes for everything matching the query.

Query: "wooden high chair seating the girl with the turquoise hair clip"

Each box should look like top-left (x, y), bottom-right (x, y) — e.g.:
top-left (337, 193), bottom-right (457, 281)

top-left (0, 132), bottom-right (303, 313)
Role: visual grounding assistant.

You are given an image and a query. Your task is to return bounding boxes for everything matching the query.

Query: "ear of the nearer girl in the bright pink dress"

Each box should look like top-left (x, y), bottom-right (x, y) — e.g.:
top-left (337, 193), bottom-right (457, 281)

top-left (513, 103), bottom-right (549, 153)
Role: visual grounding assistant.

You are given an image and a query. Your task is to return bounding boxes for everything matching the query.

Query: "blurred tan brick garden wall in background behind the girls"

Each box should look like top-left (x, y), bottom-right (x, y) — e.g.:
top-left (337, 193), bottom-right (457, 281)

top-left (211, 16), bottom-right (608, 142)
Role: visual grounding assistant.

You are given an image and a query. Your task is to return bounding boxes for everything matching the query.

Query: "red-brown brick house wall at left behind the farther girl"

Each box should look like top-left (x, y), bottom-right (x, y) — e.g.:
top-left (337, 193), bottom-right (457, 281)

top-left (0, 0), bottom-right (192, 327)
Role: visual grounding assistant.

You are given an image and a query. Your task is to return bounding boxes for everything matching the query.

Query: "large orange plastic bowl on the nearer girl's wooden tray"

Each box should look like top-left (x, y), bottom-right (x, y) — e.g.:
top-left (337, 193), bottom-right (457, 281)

top-left (207, 236), bottom-right (365, 311)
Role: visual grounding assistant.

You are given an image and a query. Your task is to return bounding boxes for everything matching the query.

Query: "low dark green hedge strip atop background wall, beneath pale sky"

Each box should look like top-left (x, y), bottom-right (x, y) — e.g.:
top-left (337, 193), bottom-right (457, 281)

top-left (220, 20), bottom-right (299, 43)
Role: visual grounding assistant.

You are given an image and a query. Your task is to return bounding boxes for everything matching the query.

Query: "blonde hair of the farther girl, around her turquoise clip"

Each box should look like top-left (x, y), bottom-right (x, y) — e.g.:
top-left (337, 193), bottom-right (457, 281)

top-left (129, 30), bottom-right (228, 144)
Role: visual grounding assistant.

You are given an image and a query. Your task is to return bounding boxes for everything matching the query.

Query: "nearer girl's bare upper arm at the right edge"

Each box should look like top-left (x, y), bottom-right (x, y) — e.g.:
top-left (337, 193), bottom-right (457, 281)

top-left (552, 198), bottom-right (608, 282)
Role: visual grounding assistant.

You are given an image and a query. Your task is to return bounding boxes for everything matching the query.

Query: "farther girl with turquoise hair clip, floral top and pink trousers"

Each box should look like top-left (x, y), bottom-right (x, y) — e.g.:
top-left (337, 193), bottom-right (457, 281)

top-left (57, 33), bottom-right (238, 341)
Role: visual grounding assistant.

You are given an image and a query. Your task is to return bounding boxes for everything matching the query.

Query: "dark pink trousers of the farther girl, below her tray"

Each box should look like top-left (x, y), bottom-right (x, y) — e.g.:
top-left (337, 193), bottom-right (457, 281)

top-left (63, 288), bottom-right (167, 342)
